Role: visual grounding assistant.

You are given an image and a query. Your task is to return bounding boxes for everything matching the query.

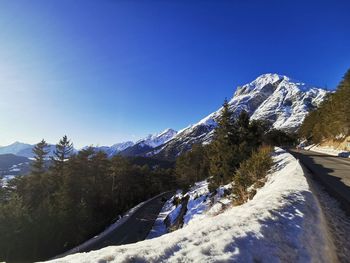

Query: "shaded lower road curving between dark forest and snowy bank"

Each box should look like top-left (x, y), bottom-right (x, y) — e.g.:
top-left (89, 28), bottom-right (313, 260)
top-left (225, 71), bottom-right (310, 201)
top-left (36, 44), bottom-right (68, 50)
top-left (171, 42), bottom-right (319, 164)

top-left (55, 192), bottom-right (174, 258)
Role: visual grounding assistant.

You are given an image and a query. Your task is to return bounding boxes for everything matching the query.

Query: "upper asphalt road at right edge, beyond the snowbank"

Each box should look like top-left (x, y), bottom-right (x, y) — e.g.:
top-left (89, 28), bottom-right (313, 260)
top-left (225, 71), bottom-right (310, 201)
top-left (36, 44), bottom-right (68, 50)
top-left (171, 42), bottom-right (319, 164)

top-left (289, 149), bottom-right (350, 214)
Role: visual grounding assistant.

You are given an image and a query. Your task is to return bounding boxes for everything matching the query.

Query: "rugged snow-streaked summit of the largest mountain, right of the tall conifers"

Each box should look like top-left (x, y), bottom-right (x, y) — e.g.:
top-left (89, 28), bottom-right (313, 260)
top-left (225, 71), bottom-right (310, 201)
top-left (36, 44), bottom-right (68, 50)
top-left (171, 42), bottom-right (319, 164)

top-left (228, 74), bottom-right (327, 131)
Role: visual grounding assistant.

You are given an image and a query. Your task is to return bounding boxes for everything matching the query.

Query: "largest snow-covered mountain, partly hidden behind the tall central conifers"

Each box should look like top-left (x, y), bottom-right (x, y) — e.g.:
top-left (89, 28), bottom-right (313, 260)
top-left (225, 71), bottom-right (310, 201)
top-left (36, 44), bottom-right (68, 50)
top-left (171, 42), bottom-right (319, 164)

top-left (152, 74), bottom-right (327, 159)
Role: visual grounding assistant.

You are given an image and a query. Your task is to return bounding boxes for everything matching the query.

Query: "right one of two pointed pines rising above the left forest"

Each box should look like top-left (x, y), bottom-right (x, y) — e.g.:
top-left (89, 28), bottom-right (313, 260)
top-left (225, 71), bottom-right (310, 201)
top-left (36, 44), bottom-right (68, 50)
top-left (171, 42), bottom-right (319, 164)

top-left (51, 135), bottom-right (73, 175)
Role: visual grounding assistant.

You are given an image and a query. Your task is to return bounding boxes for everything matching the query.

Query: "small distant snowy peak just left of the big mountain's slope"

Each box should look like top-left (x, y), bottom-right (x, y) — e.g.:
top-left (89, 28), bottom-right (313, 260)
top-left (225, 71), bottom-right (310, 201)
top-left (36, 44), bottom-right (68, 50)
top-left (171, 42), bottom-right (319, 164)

top-left (120, 129), bottom-right (177, 156)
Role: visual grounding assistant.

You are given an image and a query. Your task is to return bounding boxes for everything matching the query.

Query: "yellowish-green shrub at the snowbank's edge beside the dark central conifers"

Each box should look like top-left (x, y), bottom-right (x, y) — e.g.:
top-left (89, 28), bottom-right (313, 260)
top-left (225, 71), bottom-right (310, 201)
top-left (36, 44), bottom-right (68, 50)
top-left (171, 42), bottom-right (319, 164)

top-left (234, 146), bottom-right (273, 205)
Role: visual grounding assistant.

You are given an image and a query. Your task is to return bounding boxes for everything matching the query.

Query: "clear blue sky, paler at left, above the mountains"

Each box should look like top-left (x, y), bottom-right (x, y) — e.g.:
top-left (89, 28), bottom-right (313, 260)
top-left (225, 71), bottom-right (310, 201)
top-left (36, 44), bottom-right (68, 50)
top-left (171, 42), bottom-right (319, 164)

top-left (0, 0), bottom-right (350, 147)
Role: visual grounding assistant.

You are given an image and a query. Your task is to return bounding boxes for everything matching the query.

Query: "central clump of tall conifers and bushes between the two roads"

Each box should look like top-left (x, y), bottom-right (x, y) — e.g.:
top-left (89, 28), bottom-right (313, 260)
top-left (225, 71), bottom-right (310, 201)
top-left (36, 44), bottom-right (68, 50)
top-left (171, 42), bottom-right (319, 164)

top-left (175, 100), bottom-right (297, 195)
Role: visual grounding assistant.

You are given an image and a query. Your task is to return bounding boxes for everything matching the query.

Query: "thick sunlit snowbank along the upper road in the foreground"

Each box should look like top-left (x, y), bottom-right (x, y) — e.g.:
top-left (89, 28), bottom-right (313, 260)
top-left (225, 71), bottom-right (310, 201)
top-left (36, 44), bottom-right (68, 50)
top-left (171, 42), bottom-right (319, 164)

top-left (48, 149), bottom-right (334, 262)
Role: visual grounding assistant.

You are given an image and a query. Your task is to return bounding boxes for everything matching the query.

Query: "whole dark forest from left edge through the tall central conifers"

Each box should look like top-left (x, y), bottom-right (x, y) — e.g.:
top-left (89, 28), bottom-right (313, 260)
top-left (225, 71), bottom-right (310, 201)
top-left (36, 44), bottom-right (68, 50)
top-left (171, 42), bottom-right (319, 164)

top-left (0, 101), bottom-right (295, 262)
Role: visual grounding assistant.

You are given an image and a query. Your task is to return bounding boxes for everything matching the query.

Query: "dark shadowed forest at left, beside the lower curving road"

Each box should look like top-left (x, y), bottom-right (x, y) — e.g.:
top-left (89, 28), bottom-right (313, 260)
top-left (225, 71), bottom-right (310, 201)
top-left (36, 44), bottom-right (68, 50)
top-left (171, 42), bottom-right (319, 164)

top-left (0, 136), bottom-right (176, 262)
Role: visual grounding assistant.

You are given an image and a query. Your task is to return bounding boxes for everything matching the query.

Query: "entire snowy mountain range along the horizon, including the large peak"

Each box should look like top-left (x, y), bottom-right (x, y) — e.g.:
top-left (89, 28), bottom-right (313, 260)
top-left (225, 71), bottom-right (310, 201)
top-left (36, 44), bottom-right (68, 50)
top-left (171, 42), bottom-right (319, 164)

top-left (0, 74), bottom-right (327, 162)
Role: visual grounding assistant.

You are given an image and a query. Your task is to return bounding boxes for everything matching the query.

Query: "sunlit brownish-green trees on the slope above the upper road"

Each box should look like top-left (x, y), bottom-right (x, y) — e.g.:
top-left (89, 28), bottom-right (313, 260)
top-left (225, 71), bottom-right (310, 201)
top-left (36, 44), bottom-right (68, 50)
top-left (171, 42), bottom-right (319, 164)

top-left (299, 70), bottom-right (350, 143)
